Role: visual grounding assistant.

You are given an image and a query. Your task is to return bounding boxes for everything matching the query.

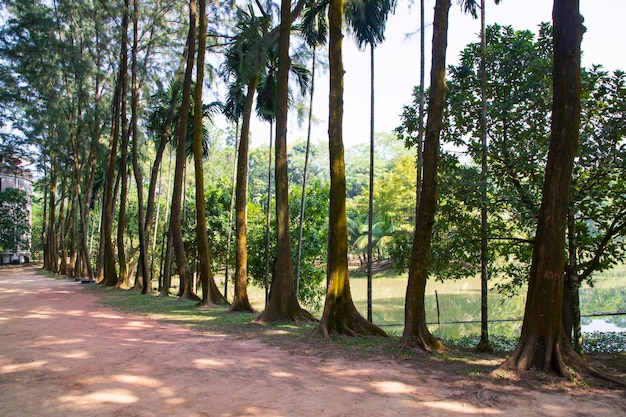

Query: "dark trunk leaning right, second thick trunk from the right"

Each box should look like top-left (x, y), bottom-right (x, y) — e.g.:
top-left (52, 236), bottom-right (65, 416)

top-left (400, 0), bottom-right (450, 351)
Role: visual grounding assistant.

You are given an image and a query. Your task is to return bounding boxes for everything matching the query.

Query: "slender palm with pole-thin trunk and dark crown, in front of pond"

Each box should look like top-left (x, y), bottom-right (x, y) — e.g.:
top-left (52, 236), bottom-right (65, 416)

top-left (346, 0), bottom-right (396, 322)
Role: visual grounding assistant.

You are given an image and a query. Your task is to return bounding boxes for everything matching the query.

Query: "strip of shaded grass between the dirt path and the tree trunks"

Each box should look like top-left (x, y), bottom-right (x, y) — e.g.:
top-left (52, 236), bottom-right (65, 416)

top-left (70, 278), bottom-right (626, 388)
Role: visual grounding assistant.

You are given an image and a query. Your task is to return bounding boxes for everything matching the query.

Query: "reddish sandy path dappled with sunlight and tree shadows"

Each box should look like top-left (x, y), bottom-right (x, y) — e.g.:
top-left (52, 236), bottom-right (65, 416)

top-left (0, 268), bottom-right (626, 417)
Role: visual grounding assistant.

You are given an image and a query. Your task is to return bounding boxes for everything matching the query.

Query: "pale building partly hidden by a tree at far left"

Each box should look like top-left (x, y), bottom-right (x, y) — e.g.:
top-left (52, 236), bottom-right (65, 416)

top-left (0, 155), bottom-right (33, 264)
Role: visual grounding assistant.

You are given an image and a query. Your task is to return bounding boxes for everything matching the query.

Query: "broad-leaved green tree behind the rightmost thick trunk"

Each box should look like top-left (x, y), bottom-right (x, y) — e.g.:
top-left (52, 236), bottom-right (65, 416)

top-left (442, 23), bottom-right (626, 352)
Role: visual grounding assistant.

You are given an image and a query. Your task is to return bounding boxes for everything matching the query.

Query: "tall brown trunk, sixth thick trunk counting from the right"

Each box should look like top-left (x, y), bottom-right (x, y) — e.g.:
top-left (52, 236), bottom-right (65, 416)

top-left (193, 0), bottom-right (227, 305)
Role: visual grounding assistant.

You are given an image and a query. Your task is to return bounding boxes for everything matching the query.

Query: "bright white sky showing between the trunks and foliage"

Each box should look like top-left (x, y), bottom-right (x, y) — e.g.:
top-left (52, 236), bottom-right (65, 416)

top-left (251, 0), bottom-right (626, 146)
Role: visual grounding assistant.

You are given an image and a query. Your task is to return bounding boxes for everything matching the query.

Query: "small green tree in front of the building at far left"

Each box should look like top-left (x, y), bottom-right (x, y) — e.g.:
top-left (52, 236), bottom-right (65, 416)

top-left (0, 188), bottom-right (30, 252)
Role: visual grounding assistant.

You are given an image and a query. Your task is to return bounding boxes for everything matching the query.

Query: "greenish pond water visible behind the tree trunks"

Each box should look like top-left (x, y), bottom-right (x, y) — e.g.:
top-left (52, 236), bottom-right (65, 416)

top-left (240, 267), bottom-right (626, 339)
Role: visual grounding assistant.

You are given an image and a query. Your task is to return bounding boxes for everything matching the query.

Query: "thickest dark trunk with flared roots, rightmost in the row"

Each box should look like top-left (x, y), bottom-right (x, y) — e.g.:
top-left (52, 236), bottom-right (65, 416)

top-left (494, 0), bottom-right (584, 376)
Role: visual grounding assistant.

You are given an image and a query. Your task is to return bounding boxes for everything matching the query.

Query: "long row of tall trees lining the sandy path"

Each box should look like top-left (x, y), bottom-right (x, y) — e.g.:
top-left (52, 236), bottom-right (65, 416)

top-left (1, 0), bottom-right (623, 375)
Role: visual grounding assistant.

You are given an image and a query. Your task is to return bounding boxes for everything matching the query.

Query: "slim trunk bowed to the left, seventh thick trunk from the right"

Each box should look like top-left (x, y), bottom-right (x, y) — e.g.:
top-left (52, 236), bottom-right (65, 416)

top-left (170, 0), bottom-right (200, 301)
